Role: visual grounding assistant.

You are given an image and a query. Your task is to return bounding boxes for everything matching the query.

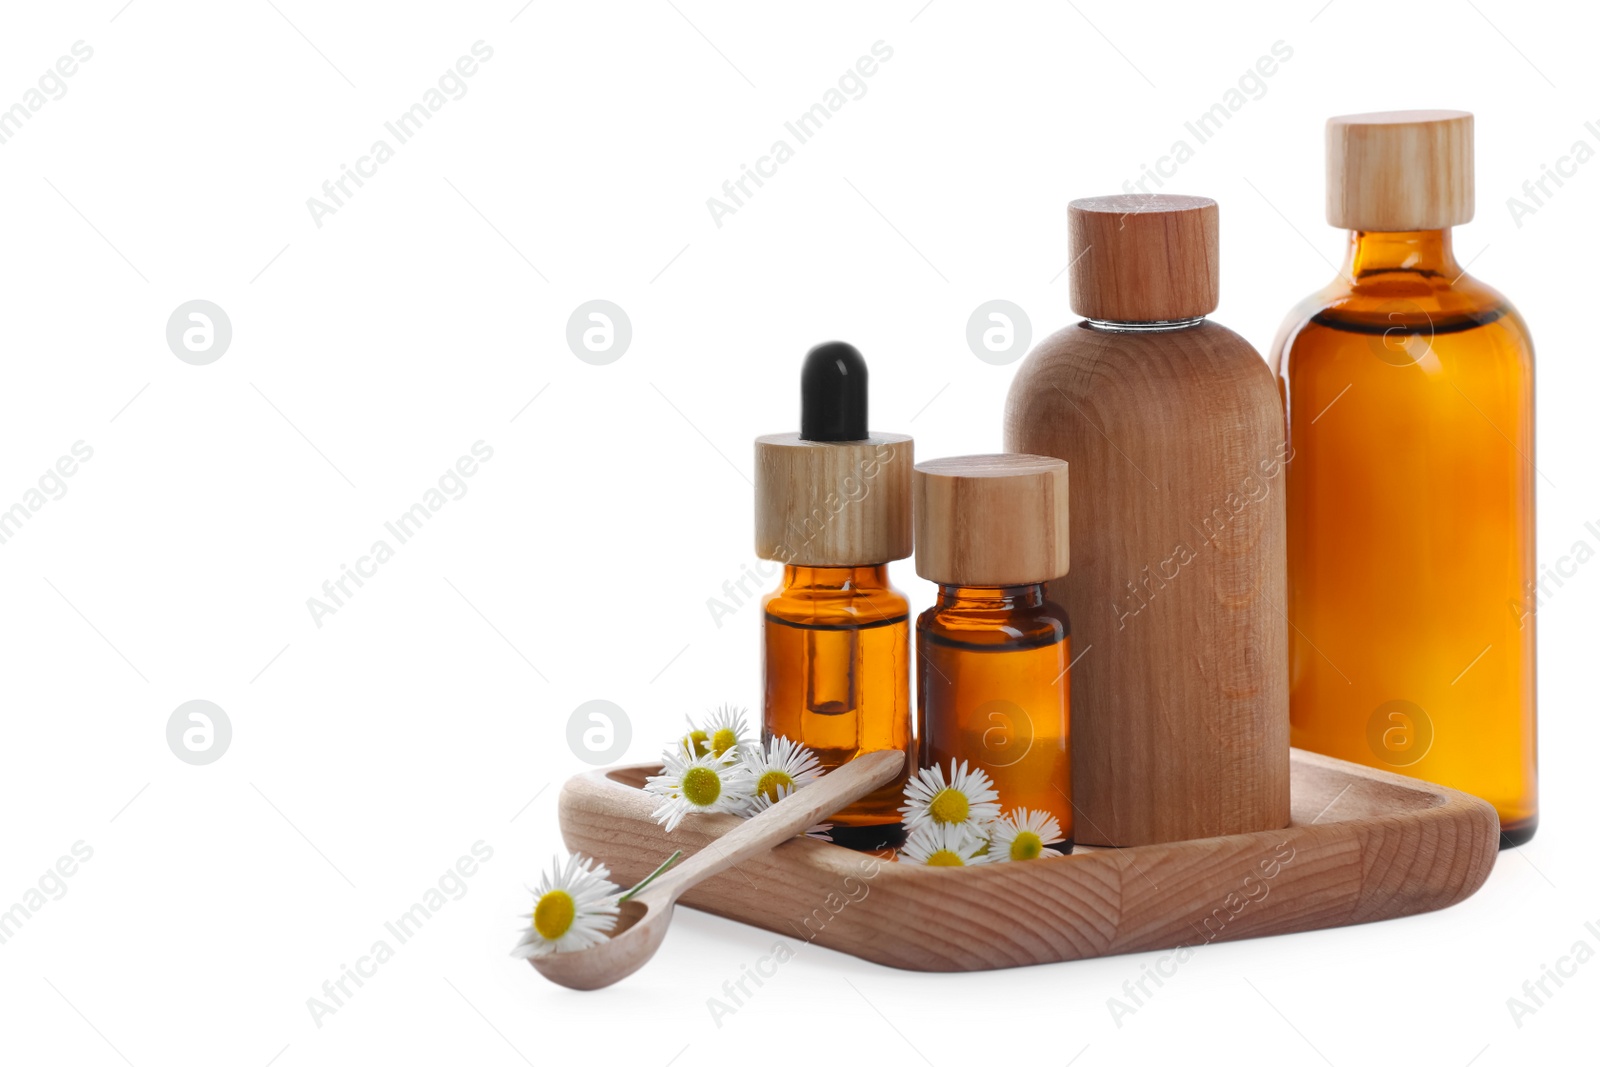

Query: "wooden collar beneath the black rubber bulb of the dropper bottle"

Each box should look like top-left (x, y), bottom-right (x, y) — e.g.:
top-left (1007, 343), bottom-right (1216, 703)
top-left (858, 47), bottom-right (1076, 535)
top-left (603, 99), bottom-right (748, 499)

top-left (755, 434), bottom-right (912, 566)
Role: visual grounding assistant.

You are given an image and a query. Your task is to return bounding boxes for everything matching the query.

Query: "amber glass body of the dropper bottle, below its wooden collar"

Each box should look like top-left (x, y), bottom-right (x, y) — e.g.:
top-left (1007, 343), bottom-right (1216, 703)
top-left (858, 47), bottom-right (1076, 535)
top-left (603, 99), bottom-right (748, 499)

top-left (762, 566), bottom-right (912, 827)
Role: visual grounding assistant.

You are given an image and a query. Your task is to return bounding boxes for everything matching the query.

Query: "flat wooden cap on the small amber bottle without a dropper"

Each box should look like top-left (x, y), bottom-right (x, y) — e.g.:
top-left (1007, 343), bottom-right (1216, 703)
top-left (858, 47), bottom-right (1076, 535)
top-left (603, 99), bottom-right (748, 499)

top-left (912, 453), bottom-right (1070, 585)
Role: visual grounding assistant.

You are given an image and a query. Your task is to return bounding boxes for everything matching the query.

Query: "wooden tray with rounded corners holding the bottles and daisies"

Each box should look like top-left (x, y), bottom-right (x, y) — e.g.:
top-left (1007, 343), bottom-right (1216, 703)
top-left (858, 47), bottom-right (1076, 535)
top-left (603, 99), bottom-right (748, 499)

top-left (560, 750), bottom-right (1499, 971)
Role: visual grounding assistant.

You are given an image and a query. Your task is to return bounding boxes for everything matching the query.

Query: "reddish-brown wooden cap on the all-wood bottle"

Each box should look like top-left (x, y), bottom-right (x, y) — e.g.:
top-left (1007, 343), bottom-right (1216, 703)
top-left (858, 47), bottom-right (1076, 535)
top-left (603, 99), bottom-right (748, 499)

top-left (1067, 194), bottom-right (1218, 322)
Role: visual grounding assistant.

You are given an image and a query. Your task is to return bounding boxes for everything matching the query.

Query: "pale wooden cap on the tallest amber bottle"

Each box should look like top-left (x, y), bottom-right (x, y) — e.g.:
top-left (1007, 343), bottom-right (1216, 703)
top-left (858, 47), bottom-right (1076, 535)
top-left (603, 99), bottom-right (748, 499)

top-left (1328, 110), bottom-right (1472, 232)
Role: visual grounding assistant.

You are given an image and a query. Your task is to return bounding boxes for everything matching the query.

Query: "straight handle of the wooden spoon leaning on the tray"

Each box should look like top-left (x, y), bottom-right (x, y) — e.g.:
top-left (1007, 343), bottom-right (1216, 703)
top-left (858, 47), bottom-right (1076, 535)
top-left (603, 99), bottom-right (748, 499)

top-left (640, 749), bottom-right (906, 901)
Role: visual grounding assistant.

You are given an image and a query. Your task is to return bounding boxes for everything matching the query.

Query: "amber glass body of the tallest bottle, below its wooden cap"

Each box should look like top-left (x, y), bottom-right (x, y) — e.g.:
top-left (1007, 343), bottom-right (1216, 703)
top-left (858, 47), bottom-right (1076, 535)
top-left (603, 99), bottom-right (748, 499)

top-left (1274, 230), bottom-right (1539, 845)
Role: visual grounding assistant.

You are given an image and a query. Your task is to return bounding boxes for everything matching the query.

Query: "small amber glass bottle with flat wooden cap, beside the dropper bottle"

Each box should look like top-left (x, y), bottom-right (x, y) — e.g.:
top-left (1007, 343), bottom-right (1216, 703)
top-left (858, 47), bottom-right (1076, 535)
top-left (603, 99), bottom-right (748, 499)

top-left (912, 454), bottom-right (1072, 849)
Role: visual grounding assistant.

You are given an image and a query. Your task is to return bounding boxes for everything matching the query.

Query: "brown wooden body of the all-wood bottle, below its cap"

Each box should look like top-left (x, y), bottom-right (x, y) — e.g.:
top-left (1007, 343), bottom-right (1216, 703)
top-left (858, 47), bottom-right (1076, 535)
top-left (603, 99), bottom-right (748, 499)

top-left (1005, 322), bottom-right (1290, 846)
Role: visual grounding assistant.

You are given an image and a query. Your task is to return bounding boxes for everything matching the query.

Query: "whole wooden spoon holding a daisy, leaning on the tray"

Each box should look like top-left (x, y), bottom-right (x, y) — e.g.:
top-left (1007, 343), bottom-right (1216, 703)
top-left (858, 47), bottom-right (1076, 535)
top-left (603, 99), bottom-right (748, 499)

top-left (528, 750), bottom-right (906, 989)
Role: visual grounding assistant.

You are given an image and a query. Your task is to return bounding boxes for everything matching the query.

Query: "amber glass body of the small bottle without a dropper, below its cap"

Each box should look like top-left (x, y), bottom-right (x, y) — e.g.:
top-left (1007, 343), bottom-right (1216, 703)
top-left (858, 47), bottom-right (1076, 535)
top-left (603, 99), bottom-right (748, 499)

top-left (917, 584), bottom-right (1072, 848)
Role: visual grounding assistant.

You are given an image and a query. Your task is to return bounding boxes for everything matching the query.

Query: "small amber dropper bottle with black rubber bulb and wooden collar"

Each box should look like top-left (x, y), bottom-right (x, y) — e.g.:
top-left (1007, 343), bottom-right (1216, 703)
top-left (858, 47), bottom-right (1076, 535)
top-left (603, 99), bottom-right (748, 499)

top-left (755, 341), bottom-right (912, 846)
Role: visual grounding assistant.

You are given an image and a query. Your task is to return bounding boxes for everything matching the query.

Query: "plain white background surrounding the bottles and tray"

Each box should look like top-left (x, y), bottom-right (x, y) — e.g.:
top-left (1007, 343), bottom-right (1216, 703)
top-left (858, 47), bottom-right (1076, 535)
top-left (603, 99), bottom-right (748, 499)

top-left (0, 0), bottom-right (1600, 1067)
